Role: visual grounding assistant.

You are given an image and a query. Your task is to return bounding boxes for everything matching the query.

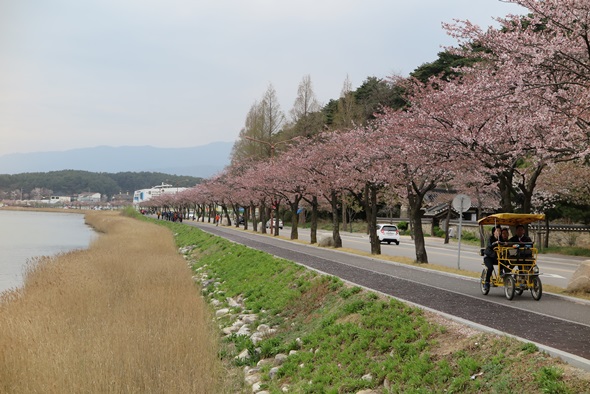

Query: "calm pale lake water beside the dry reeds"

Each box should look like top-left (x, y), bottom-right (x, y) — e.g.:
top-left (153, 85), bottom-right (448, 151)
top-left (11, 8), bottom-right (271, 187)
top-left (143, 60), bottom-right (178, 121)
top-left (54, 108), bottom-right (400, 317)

top-left (0, 210), bottom-right (96, 293)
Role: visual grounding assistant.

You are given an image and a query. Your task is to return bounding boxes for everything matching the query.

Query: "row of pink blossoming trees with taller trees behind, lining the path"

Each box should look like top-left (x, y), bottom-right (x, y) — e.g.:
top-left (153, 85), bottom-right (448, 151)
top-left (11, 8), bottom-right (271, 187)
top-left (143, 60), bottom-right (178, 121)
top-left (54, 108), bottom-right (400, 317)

top-left (142, 0), bottom-right (590, 263)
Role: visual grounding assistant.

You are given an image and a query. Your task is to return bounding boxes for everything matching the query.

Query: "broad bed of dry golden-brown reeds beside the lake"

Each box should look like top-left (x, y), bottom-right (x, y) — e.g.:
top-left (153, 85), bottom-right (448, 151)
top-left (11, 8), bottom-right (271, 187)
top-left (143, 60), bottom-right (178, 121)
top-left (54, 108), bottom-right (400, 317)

top-left (0, 212), bottom-right (224, 393)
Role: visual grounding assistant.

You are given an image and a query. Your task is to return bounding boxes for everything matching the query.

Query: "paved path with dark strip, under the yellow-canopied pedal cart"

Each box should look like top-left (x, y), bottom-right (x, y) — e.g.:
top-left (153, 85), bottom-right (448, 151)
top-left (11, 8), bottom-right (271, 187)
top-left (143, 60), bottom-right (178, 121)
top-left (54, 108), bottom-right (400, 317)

top-left (185, 221), bottom-right (590, 370)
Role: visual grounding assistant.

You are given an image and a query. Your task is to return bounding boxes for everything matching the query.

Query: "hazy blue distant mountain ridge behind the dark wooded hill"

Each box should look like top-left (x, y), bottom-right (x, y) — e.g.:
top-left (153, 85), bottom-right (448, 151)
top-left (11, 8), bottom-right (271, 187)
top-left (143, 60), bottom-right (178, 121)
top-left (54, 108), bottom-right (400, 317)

top-left (0, 142), bottom-right (233, 178)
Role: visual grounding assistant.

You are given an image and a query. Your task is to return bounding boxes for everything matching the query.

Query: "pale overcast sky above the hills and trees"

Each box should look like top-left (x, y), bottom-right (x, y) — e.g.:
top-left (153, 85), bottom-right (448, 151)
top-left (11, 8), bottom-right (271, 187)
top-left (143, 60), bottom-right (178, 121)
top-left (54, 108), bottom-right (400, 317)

top-left (0, 0), bottom-right (523, 156)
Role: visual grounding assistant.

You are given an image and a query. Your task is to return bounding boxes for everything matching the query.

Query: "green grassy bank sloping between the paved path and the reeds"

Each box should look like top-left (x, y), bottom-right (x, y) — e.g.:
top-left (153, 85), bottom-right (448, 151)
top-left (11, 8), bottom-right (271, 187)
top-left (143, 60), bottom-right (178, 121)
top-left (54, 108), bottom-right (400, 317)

top-left (145, 217), bottom-right (590, 393)
